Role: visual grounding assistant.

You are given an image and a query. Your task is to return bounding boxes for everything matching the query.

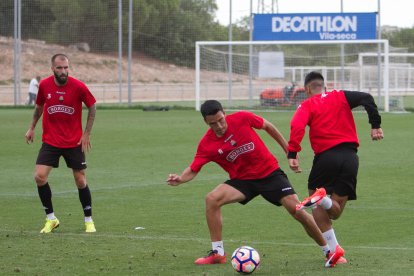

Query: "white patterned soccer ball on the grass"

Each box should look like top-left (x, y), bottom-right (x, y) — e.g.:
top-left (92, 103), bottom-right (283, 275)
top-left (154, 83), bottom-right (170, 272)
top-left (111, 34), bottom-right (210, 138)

top-left (231, 246), bottom-right (260, 274)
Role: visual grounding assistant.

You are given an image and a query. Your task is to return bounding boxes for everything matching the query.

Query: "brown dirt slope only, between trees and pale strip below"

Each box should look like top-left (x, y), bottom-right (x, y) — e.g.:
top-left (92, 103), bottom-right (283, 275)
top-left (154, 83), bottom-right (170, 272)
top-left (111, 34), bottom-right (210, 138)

top-left (0, 37), bottom-right (231, 84)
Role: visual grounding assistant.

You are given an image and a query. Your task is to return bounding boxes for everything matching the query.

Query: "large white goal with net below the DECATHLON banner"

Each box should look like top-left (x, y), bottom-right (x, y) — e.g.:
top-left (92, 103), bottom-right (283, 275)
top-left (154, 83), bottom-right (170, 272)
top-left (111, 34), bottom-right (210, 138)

top-left (195, 39), bottom-right (390, 112)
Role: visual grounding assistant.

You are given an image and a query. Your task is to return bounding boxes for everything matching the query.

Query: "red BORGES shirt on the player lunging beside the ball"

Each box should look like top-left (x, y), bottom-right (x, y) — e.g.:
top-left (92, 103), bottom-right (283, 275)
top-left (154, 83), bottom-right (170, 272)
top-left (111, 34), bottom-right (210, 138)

top-left (190, 111), bottom-right (279, 180)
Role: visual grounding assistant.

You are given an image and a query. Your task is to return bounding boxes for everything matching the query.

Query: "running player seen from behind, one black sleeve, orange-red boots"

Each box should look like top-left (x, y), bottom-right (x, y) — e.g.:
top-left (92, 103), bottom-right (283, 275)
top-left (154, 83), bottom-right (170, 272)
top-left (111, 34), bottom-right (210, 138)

top-left (288, 72), bottom-right (384, 266)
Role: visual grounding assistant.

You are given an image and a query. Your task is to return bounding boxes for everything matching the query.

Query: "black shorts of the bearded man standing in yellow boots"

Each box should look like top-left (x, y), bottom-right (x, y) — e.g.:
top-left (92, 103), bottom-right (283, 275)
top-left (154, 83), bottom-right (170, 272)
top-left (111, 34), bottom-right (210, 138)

top-left (36, 143), bottom-right (86, 170)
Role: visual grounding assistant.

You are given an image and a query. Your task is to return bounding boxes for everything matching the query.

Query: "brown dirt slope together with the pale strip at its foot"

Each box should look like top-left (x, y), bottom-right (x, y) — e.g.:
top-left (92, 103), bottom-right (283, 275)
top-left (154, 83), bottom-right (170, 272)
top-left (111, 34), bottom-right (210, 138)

top-left (0, 37), bottom-right (282, 104)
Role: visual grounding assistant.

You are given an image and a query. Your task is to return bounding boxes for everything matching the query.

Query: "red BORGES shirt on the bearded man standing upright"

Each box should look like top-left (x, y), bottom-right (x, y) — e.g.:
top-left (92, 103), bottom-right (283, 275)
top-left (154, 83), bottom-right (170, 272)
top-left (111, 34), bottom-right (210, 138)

top-left (36, 75), bottom-right (96, 148)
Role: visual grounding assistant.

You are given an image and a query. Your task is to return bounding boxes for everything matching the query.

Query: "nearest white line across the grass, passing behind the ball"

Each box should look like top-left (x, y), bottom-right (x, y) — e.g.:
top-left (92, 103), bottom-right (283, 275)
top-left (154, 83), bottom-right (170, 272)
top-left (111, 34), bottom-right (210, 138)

top-left (0, 229), bottom-right (414, 251)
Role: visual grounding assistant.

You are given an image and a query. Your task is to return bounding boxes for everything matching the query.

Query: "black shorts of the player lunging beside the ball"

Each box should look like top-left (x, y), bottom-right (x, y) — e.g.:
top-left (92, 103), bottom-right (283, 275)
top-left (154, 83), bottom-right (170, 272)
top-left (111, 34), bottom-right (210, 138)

top-left (225, 168), bottom-right (296, 206)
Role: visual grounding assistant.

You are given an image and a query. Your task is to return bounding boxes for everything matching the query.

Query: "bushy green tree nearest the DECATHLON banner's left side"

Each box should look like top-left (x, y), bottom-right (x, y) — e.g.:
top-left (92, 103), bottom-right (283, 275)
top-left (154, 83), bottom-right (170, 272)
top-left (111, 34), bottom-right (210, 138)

top-left (137, 0), bottom-right (224, 66)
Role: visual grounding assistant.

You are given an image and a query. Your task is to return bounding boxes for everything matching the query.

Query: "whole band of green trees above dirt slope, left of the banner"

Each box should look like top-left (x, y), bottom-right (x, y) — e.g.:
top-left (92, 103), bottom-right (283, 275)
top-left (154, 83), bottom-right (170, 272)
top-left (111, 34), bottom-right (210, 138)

top-left (0, 0), bottom-right (248, 66)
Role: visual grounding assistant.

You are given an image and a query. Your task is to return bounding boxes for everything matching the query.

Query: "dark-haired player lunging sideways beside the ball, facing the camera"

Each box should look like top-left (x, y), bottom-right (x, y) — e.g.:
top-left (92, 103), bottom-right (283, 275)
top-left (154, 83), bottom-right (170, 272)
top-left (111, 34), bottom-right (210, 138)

top-left (167, 100), bottom-right (341, 265)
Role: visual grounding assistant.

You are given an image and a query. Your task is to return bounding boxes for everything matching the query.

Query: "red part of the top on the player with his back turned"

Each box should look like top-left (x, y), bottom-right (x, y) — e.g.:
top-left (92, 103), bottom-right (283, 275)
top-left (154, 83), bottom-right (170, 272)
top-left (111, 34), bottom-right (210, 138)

top-left (288, 90), bottom-right (359, 154)
